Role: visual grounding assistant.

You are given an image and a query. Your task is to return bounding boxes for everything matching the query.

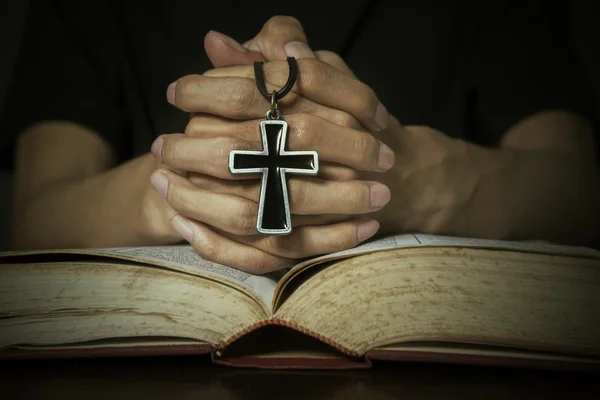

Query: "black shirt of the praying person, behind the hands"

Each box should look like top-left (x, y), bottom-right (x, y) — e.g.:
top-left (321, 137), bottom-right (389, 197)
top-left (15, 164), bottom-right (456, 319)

top-left (0, 0), bottom-right (585, 167)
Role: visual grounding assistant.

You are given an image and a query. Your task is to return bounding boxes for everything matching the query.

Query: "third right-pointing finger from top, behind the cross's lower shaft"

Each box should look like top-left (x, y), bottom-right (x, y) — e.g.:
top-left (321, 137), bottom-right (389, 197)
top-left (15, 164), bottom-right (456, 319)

top-left (190, 174), bottom-right (391, 215)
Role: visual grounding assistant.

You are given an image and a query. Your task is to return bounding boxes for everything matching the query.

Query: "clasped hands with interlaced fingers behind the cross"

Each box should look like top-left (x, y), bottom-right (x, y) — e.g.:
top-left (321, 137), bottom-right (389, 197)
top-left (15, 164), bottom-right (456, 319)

top-left (152, 18), bottom-right (394, 273)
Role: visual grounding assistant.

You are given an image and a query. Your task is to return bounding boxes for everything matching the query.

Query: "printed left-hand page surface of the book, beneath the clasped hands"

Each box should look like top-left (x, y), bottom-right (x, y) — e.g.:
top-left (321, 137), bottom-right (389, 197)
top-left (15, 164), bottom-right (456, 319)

top-left (72, 246), bottom-right (283, 306)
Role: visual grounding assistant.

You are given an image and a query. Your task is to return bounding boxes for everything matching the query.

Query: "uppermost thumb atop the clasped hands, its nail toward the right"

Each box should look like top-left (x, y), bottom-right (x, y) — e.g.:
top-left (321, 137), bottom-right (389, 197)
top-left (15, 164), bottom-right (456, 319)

top-left (244, 16), bottom-right (316, 61)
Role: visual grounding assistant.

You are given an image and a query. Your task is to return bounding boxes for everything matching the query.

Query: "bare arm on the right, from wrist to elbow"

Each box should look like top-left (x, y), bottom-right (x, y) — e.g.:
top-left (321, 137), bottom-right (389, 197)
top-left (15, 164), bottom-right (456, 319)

top-left (376, 114), bottom-right (600, 246)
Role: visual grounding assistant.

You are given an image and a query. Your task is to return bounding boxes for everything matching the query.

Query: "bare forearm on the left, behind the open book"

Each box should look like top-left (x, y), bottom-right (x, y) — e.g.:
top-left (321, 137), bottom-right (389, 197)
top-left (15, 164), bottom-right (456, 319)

top-left (13, 154), bottom-right (173, 249)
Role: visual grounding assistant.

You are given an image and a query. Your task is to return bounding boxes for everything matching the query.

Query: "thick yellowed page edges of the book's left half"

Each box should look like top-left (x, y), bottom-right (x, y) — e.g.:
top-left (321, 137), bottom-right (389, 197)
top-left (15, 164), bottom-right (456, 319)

top-left (0, 262), bottom-right (267, 348)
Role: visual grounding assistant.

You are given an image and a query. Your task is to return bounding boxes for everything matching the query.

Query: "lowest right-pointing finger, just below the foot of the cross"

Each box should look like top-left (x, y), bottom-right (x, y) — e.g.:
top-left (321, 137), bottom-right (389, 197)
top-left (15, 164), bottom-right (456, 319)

top-left (220, 219), bottom-right (379, 259)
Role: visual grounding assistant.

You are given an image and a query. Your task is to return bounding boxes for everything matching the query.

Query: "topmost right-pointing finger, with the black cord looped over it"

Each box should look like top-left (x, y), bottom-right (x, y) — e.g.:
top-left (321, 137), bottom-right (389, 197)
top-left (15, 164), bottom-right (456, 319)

top-left (199, 59), bottom-right (389, 131)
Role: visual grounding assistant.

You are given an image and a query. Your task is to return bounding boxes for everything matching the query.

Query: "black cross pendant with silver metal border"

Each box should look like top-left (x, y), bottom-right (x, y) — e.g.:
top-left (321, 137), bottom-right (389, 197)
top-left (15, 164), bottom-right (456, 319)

top-left (229, 120), bottom-right (319, 235)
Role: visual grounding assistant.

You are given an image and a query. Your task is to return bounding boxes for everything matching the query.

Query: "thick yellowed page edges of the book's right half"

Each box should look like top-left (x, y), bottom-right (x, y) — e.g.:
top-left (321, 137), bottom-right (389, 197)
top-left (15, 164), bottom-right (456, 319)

top-left (275, 247), bottom-right (600, 357)
